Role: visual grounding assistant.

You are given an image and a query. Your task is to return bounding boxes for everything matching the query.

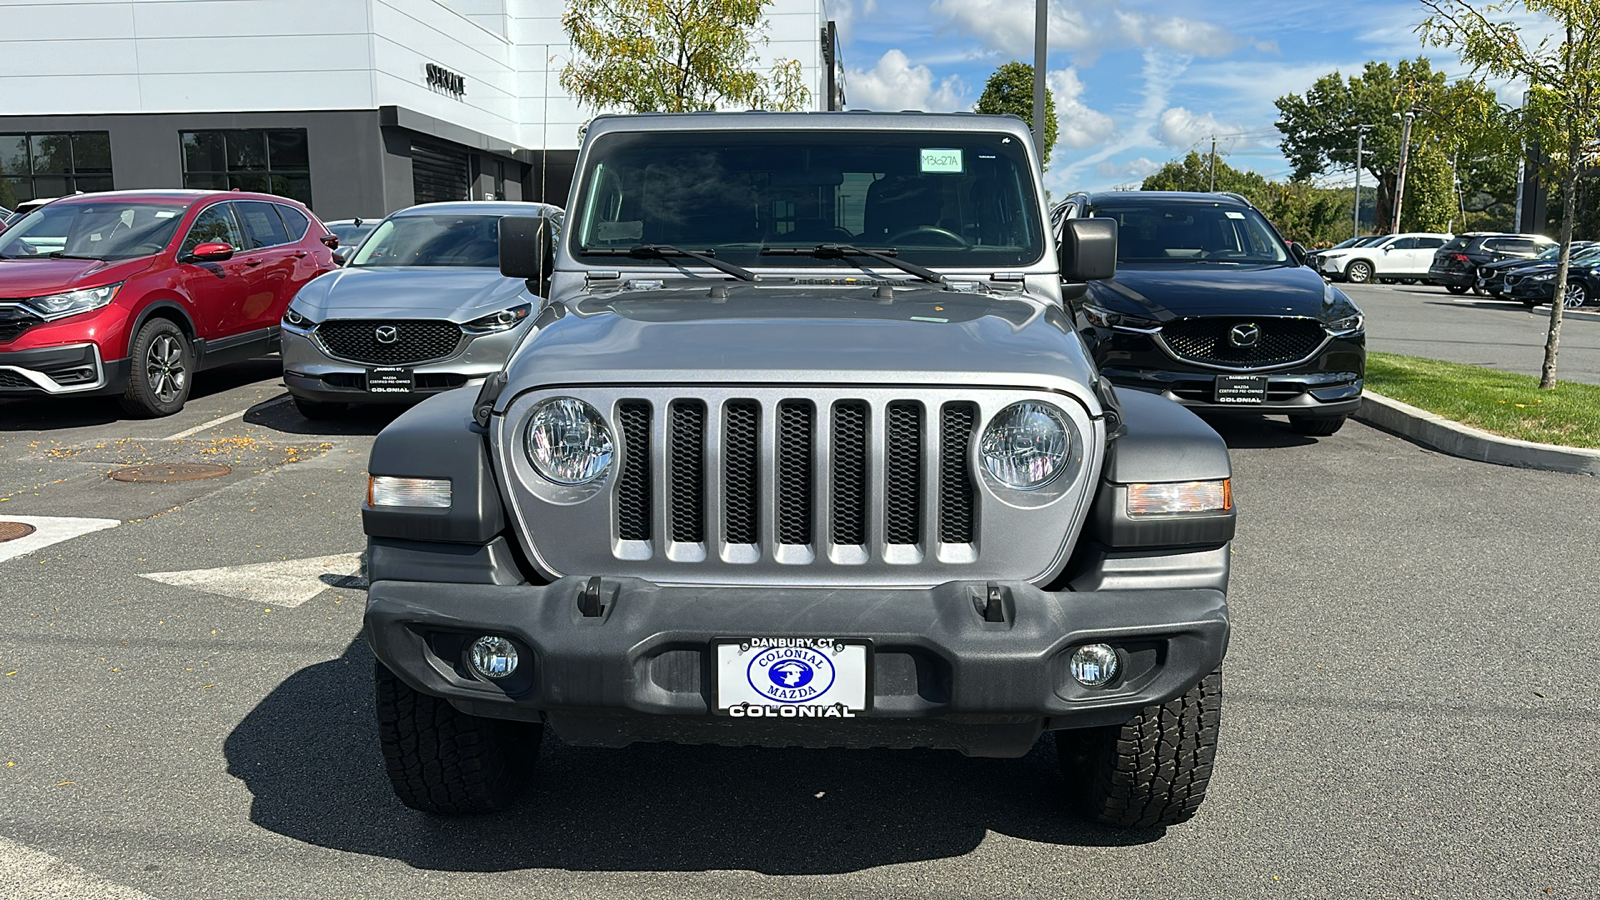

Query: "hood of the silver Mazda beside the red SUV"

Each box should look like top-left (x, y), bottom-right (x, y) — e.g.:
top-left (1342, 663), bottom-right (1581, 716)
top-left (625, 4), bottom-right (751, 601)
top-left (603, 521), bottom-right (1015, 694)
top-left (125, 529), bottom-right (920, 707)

top-left (293, 266), bottom-right (533, 323)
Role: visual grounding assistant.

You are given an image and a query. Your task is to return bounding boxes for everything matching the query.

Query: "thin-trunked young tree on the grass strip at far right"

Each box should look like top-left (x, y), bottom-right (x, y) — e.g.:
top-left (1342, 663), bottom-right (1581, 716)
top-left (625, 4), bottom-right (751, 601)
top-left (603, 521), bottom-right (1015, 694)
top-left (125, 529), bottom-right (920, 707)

top-left (1418, 0), bottom-right (1600, 389)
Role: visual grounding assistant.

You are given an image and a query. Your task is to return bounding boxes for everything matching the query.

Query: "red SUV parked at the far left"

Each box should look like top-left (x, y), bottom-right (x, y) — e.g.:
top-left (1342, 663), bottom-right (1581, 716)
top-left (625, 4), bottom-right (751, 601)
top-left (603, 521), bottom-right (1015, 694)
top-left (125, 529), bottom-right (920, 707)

top-left (0, 191), bottom-right (338, 416)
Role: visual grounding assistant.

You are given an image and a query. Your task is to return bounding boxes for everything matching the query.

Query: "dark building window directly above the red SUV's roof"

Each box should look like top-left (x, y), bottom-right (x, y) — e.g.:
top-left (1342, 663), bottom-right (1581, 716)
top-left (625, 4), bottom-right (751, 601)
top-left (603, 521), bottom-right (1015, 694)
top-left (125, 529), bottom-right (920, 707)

top-left (179, 128), bottom-right (310, 207)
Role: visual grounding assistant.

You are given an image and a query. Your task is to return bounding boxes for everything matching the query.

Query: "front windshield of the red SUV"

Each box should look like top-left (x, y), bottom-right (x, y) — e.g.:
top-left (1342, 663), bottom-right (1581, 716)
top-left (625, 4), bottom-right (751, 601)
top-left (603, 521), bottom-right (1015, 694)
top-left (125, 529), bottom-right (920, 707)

top-left (0, 200), bottom-right (189, 259)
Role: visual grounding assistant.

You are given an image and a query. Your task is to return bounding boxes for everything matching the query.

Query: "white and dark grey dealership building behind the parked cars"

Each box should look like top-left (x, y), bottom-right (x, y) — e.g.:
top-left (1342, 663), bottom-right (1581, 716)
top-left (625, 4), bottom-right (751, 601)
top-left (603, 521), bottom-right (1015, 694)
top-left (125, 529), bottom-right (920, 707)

top-left (0, 0), bottom-right (843, 219)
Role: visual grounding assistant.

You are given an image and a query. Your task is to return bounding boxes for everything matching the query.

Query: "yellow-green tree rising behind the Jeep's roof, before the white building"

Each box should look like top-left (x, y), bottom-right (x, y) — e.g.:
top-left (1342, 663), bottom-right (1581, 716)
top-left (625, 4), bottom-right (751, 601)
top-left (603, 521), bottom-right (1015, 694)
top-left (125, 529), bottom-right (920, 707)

top-left (560, 0), bottom-right (811, 112)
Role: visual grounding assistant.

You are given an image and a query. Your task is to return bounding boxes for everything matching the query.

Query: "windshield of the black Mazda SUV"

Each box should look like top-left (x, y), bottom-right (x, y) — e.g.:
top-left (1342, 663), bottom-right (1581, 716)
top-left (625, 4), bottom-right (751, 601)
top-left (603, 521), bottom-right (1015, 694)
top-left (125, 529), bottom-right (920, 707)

top-left (1090, 199), bottom-right (1290, 264)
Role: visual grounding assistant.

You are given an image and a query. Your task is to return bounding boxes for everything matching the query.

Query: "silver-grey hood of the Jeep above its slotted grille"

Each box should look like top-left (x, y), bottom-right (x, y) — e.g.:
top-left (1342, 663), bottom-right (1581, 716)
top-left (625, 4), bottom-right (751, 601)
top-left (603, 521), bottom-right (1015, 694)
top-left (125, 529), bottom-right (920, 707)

top-left (502, 282), bottom-right (1099, 403)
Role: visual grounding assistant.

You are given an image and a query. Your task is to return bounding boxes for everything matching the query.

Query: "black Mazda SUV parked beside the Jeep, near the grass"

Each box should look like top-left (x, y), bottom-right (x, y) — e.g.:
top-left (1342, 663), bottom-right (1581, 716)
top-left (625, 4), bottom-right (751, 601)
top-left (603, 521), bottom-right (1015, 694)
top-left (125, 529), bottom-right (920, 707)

top-left (1051, 191), bottom-right (1366, 436)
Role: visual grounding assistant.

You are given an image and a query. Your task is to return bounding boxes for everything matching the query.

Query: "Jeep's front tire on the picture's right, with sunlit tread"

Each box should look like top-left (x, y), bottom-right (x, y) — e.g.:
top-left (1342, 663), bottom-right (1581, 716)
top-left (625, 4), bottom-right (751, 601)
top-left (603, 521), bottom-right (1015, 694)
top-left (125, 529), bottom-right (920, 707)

top-left (1056, 669), bottom-right (1222, 828)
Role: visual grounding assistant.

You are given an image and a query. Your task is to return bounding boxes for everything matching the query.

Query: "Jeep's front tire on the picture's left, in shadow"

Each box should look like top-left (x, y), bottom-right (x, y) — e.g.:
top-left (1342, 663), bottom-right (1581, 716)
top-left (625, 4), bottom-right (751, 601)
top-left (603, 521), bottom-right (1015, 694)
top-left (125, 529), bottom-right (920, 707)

top-left (373, 663), bottom-right (544, 815)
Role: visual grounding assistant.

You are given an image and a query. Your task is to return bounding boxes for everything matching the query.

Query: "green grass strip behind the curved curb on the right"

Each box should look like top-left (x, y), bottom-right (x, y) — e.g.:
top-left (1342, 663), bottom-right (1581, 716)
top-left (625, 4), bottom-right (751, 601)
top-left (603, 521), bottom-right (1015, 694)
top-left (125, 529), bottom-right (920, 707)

top-left (1366, 352), bottom-right (1600, 448)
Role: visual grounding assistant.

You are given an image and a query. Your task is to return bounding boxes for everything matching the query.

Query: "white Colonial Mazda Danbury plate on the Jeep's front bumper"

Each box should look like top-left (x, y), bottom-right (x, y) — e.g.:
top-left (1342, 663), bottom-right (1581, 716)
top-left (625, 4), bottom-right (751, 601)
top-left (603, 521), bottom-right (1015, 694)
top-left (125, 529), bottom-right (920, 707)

top-left (714, 637), bottom-right (872, 719)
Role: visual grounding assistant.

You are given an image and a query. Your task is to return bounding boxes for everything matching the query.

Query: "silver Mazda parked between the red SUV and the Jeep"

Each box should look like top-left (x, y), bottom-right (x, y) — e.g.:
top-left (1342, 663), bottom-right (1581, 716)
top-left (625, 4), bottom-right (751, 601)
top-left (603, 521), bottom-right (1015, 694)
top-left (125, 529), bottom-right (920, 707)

top-left (283, 202), bottom-right (560, 418)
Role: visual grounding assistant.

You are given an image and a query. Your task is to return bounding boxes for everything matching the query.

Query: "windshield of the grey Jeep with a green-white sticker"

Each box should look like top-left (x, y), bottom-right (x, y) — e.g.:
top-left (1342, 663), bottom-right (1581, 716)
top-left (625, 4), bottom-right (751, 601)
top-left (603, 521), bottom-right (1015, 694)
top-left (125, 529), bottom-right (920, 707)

top-left (568, 130), bottom-right (1045, 267)
